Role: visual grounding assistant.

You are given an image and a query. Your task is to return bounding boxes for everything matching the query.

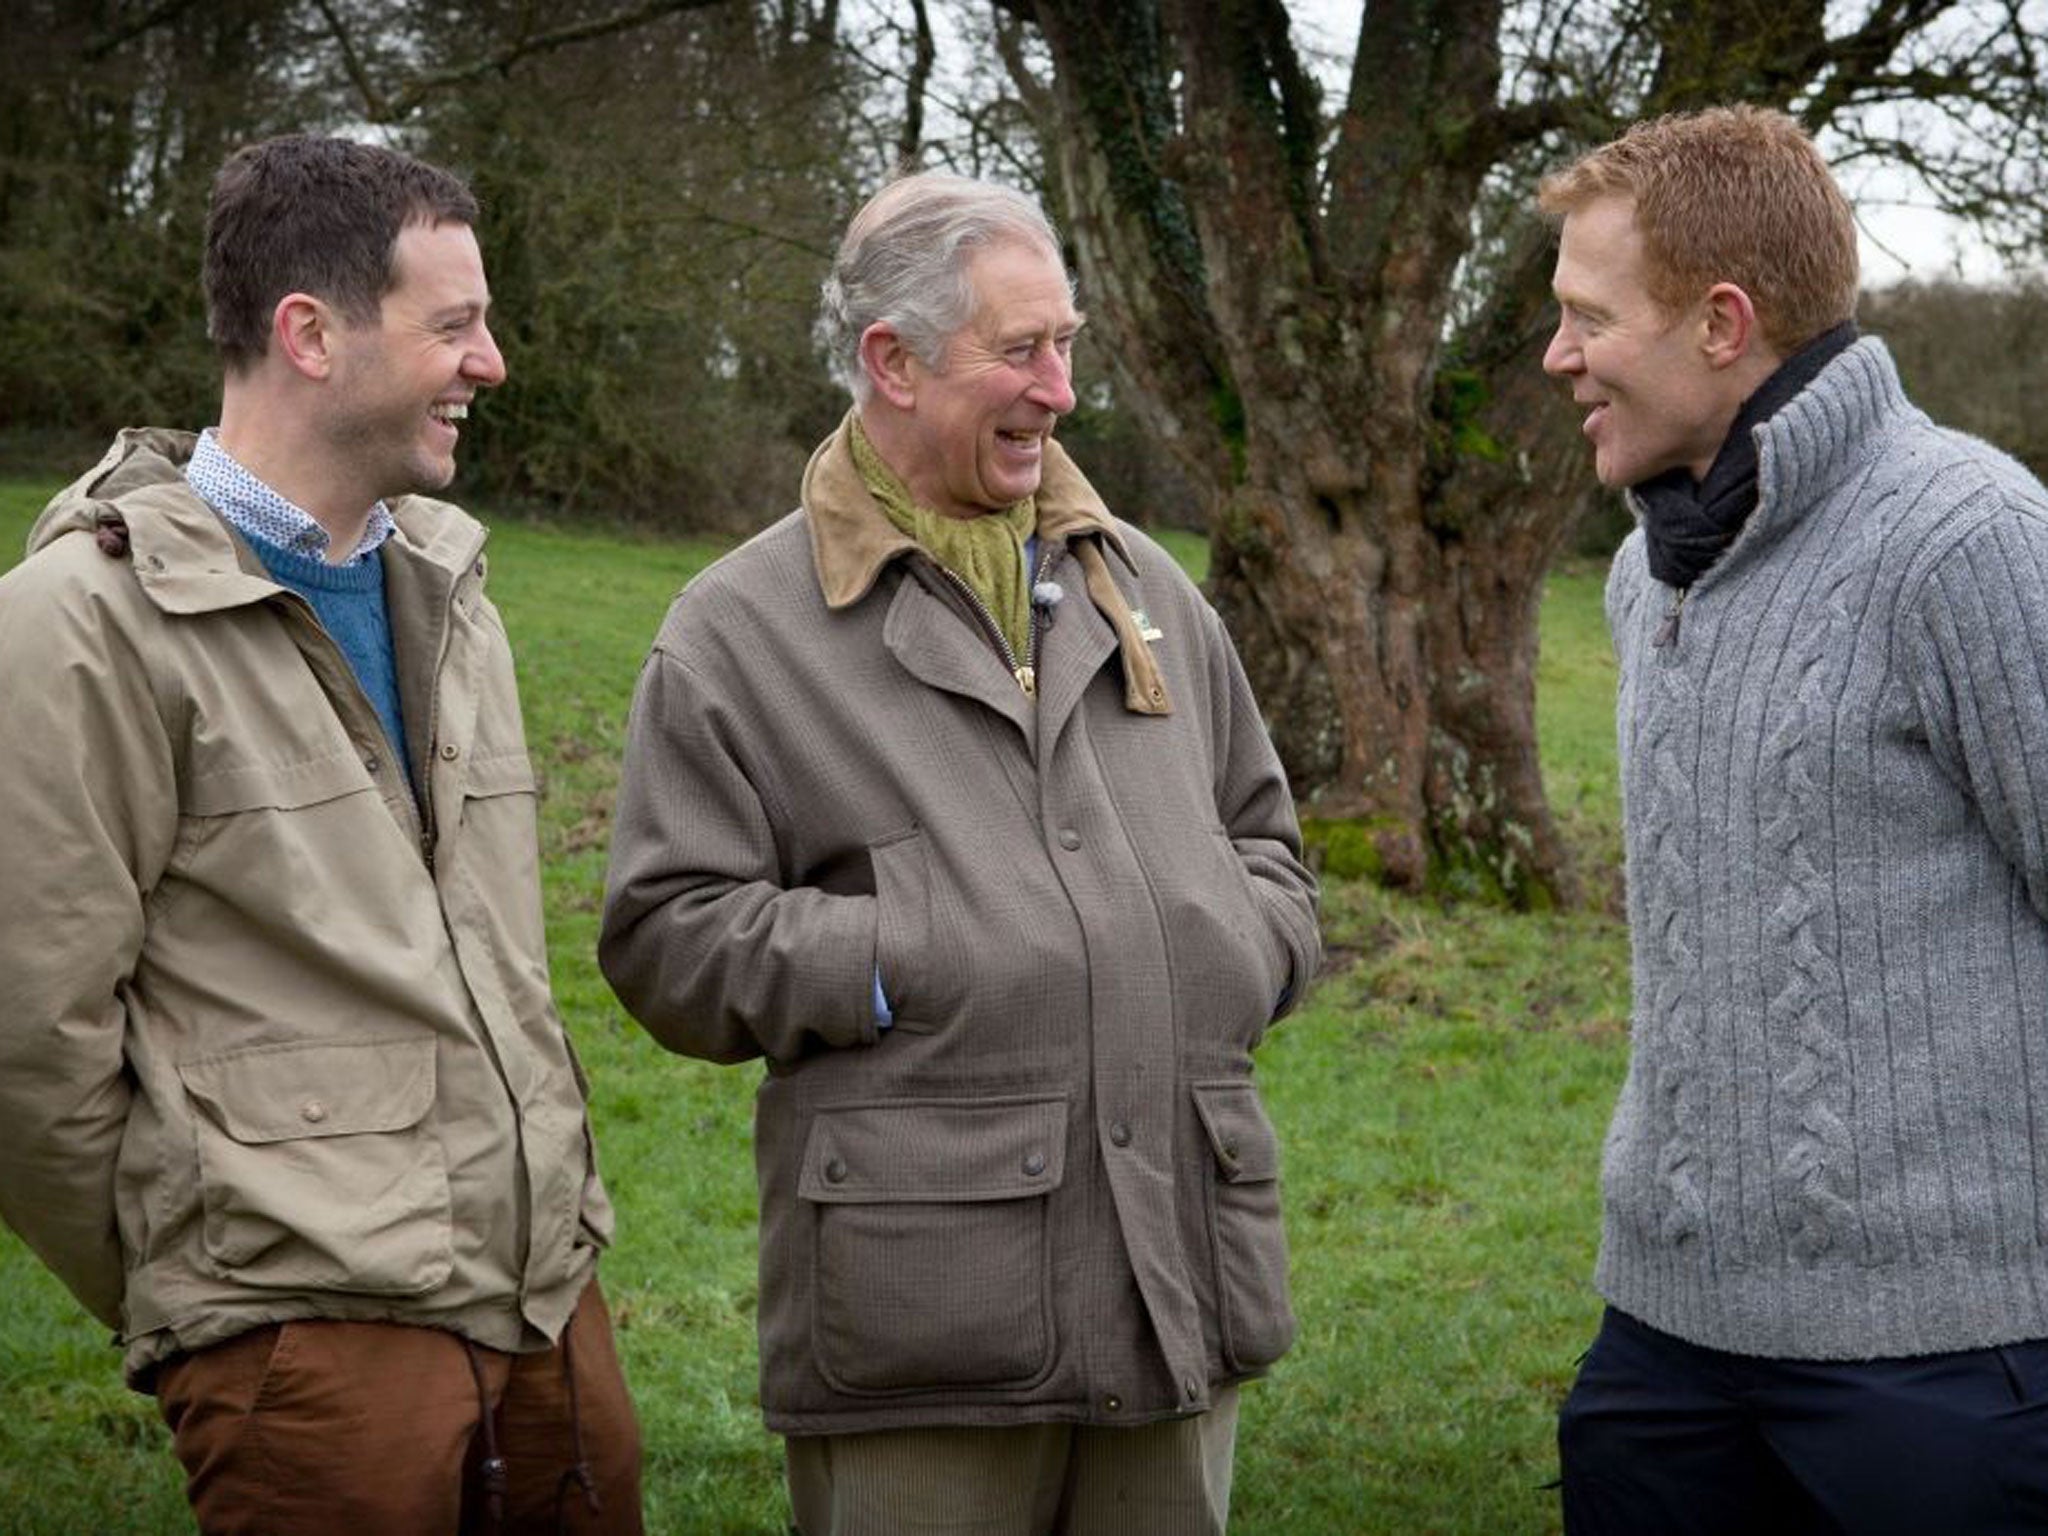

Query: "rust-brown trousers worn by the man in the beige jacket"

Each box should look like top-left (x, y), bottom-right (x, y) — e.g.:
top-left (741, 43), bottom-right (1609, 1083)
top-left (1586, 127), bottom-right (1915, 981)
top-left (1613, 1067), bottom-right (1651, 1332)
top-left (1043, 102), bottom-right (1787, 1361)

top-left (156, 1280), bottom-right (641, 1536)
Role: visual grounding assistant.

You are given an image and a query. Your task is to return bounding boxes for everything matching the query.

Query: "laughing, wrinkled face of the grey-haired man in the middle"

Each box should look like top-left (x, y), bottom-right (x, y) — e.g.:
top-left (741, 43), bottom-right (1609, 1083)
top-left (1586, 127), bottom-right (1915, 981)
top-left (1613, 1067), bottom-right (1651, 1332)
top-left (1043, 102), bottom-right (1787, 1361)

top-left (891, 242), bottom-right (1081, 518)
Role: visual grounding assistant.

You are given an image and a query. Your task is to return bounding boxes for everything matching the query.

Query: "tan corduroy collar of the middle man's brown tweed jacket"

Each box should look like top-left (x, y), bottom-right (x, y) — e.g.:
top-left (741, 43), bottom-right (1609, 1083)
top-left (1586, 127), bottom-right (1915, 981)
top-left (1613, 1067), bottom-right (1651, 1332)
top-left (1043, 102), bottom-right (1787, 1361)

top-left (803, 412), bottom-right (1137, 608)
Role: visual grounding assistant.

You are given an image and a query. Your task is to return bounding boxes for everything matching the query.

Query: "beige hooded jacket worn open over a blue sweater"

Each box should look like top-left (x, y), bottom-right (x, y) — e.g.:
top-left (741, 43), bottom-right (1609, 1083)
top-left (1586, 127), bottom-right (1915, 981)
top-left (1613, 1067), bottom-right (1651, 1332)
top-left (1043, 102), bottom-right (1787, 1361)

top-left (0, 430), bottom-right (612, 1386)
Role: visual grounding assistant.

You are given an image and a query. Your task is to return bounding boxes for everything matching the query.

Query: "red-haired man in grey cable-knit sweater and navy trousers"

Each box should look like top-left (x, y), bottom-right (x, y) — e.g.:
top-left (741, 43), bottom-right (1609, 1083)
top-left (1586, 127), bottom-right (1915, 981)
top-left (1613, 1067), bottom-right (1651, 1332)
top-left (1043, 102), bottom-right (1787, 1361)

top-left (1540, 109), bottom-right (2048, 1536)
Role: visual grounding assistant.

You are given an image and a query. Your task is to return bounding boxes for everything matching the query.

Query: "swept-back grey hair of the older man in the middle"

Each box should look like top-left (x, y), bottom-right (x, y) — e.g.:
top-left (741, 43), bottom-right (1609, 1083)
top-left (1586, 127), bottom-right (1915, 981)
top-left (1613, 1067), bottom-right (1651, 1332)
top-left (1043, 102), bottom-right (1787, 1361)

top-left (819, 170), bottom-right (1059, 406)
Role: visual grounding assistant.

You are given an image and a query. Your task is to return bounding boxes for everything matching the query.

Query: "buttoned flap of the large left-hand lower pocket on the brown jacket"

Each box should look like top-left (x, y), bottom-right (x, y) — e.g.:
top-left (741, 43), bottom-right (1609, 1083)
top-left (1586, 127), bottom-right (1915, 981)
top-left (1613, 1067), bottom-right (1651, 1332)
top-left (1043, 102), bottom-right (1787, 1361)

top-left (797, 1098), bottom-right (1067, 1204)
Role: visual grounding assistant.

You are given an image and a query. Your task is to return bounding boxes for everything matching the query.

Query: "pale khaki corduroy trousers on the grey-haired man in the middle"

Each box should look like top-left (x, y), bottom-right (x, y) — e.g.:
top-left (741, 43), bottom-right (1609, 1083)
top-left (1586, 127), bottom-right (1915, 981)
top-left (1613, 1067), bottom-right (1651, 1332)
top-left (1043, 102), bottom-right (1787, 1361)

top-left (788, 1386), bottom-right (1237, 1536)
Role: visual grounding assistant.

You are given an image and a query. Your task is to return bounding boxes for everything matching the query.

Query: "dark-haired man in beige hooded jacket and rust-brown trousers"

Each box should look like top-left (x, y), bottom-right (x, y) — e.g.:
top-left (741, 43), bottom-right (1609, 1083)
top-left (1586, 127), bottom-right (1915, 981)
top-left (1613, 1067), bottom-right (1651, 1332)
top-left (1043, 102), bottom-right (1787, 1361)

top-left (0, 137), bottom-right (641, 1536)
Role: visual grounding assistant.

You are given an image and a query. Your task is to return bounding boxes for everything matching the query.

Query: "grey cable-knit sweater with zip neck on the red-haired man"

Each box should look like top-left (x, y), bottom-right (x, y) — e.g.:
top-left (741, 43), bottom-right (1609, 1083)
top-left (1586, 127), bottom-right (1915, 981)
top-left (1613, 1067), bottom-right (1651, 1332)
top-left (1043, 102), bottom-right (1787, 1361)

top-left (1597, 340), bottom-right (2048, 1360)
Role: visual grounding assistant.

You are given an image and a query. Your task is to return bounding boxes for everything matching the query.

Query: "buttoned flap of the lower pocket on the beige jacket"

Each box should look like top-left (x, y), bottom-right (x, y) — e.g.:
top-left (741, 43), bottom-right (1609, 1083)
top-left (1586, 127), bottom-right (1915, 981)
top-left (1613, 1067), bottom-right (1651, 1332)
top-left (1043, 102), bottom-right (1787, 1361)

top-left (178, 1038), bottom-right (434, 1145)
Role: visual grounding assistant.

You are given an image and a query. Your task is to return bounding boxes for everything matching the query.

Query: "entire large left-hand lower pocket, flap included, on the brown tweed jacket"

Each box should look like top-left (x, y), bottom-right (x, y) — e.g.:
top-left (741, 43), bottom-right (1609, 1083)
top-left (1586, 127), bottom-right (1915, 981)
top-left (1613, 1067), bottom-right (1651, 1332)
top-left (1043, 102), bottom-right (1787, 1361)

top-left (797, 1098), bottom-right (1067, 1395)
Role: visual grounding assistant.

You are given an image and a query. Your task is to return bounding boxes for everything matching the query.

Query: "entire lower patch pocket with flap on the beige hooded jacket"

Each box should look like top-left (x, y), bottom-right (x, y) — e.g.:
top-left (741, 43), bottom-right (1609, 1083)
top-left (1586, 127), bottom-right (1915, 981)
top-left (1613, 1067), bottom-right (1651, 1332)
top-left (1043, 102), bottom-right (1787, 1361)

top-left (178, 1038), bottom-right (455, 1294)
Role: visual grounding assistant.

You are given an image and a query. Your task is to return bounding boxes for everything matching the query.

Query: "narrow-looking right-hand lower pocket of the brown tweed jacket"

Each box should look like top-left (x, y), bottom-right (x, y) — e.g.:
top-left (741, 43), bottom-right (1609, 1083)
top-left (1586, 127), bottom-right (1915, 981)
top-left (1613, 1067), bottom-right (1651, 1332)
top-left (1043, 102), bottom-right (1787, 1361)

top-left (1194, 1081), bottom-right (1294, 1370)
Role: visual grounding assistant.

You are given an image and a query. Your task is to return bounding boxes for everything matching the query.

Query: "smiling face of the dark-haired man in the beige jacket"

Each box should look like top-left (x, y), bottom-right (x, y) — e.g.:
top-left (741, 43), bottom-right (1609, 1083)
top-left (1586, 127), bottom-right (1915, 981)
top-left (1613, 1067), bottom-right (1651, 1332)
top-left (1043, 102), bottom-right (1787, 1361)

top-left (326, 223), bottom-right (506, 498)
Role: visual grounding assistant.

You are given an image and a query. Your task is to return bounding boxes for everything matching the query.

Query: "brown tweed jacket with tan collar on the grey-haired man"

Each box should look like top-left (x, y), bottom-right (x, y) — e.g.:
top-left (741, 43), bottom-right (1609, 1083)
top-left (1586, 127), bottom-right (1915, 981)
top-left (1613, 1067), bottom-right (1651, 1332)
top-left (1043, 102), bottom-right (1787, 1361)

top-left (600, 415), bottom-right (1319, 1434)
